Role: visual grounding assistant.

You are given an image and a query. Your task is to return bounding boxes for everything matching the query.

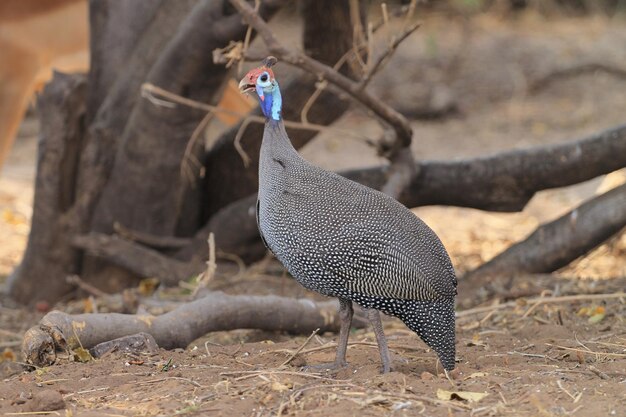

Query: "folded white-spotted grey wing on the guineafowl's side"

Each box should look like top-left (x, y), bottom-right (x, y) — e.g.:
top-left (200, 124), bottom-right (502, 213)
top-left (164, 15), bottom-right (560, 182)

top-left (282, 164), bottom-right (456, 300)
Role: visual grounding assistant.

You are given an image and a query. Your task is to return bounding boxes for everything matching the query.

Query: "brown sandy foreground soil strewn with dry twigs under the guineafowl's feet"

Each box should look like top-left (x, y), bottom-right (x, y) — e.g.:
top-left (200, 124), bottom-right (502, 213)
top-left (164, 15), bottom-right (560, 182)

top-left (0, 272), bottom-right (626, 416)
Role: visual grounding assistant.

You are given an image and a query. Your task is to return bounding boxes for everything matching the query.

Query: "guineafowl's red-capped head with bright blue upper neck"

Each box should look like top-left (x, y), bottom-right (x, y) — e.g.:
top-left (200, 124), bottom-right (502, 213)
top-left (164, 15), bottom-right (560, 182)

top-left (239, 56), bottom-right (282, 120)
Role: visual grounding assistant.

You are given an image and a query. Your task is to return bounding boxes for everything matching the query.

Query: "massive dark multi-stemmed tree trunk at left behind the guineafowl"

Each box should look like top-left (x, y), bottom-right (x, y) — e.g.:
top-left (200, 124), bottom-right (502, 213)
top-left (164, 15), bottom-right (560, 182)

top-left (10, 0), bottom-right (364, 303)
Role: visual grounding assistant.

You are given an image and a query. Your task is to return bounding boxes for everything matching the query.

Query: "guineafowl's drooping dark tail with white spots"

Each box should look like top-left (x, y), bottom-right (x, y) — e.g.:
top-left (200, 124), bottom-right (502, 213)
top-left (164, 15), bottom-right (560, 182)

top-left (400, 299), bottom-right (456, 371)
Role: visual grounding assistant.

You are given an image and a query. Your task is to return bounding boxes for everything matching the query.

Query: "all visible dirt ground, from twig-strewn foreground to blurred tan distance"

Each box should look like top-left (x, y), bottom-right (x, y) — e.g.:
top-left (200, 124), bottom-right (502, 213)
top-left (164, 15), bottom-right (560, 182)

top-left (0, 7), bottom-right (626, 417)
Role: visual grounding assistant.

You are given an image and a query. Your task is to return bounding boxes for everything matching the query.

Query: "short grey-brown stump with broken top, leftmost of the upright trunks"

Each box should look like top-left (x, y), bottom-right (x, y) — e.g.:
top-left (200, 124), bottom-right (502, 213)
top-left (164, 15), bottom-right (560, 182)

top-left (8, 73), bottom-right (86, 304)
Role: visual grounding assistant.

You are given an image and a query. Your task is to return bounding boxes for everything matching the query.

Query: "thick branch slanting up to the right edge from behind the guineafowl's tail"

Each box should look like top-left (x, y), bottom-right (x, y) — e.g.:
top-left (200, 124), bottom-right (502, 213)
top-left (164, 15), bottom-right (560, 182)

top-left (459, 184), bottom-right (626, 284)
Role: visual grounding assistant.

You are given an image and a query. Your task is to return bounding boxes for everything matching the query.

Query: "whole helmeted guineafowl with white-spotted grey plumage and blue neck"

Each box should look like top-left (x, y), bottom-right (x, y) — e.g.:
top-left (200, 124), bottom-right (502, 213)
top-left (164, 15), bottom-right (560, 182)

top-left (239, 57), bottom-right (457, 372)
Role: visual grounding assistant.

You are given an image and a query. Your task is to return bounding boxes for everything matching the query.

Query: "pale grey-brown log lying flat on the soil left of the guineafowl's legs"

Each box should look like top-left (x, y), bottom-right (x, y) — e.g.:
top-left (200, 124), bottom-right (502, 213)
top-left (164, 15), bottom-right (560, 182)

top-left (22, 292), bottom-right (366, 366)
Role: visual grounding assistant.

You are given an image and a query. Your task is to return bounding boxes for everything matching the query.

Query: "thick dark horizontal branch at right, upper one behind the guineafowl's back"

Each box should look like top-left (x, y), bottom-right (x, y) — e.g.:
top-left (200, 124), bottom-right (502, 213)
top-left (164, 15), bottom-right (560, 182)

top-left (348, 125), bottom-right (626, 212)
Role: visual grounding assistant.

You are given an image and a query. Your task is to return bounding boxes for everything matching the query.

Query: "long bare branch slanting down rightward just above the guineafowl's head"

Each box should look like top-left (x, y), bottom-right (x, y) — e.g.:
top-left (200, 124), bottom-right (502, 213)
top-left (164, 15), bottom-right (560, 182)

top-left (230, 0), bottom-right (413, 154)
